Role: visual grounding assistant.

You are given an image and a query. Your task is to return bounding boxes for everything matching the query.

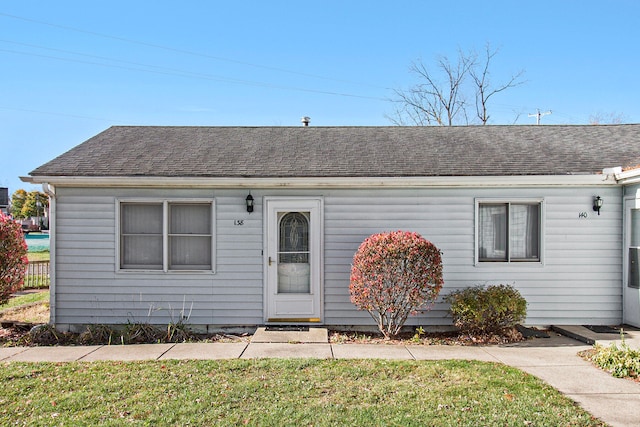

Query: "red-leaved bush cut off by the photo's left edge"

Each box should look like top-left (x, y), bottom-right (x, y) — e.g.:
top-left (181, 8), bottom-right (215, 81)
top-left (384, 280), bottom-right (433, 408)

top-left (0, 212), bottom-right (29, 304)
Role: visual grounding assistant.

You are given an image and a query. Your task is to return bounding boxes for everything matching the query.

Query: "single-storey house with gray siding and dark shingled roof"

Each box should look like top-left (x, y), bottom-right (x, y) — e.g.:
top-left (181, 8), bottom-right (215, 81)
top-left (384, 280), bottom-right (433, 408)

top-left (23, 125), bottom-right (640, 329)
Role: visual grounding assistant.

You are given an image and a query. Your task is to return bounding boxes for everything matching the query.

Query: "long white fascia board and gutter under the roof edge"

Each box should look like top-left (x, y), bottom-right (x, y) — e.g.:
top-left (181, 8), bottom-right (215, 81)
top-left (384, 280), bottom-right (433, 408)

top-left (20, 174), bottom-right (619, 188)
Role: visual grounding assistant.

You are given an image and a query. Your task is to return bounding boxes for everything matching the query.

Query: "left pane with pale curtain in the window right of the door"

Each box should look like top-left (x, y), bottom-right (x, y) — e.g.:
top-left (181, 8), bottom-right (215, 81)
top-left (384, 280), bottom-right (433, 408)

top-left (478, 204), bottom-right (507, 261)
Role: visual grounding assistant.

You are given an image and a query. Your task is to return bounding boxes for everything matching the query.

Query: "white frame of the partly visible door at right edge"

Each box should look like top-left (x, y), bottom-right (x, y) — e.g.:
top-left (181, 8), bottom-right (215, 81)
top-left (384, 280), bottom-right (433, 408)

top-left (622, 197), bottom-right (640, 327)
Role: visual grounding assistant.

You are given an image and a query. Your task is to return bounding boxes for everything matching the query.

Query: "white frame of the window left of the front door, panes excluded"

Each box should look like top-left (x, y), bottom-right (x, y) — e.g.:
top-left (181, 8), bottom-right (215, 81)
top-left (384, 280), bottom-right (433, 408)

top-left (115, 198), bottom-right (217, 274)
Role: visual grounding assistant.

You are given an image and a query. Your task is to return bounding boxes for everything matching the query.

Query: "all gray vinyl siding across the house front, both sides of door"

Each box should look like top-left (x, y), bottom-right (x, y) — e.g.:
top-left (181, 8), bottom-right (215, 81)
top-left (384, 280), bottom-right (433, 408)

top-left (54, 187), bottom-right (622, 326)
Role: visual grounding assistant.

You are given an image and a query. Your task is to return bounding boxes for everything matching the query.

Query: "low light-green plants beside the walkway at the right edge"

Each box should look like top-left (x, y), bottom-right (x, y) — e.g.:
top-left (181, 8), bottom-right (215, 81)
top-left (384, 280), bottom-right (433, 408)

top-left (588, 332), bottom-right (640, 378)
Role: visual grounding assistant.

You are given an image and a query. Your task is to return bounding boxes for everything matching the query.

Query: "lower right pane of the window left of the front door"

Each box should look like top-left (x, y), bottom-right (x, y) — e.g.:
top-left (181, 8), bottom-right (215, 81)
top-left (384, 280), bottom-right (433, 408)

top-left (169, 236), bottom-right (211, 270)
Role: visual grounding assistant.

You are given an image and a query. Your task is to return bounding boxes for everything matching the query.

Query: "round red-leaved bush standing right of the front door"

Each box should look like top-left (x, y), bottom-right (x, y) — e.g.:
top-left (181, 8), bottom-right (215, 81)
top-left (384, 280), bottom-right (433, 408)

top-left (349, 231), bottom-right (443, 338)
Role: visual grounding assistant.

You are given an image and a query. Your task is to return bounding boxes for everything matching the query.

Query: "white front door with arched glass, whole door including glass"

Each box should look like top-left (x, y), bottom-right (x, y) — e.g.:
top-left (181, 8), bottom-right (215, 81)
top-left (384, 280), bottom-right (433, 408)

top-left (265, 198), bottom-right (323, 323)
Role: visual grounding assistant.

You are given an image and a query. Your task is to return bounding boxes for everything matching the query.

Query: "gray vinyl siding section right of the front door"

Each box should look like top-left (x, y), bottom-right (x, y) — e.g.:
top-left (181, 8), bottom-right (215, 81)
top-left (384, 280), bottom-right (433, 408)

top-left (325, 188), bottom-right (622, 325)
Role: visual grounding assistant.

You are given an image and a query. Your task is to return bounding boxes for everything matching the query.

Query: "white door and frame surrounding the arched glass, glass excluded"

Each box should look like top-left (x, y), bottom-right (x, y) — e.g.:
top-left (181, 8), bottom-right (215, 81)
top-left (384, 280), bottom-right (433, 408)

top-left (263, 196), bottom-right (324, 324)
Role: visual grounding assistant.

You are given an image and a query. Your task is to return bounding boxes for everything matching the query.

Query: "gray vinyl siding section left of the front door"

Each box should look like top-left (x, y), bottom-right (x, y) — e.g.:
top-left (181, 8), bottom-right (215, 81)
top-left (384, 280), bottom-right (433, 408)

top-left (55, 188), bottom-right (262, 325)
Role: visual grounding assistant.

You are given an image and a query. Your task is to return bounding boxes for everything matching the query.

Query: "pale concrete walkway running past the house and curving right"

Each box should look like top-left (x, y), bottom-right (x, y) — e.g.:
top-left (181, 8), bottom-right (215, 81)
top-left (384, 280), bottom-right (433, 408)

top-left (0, 332), bottom-right (640, 426)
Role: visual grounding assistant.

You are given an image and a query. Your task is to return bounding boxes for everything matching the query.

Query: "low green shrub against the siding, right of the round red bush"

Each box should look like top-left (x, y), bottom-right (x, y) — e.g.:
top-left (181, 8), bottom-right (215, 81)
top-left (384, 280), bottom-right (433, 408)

top-left (444, 285), bottom-right (527, 333)
